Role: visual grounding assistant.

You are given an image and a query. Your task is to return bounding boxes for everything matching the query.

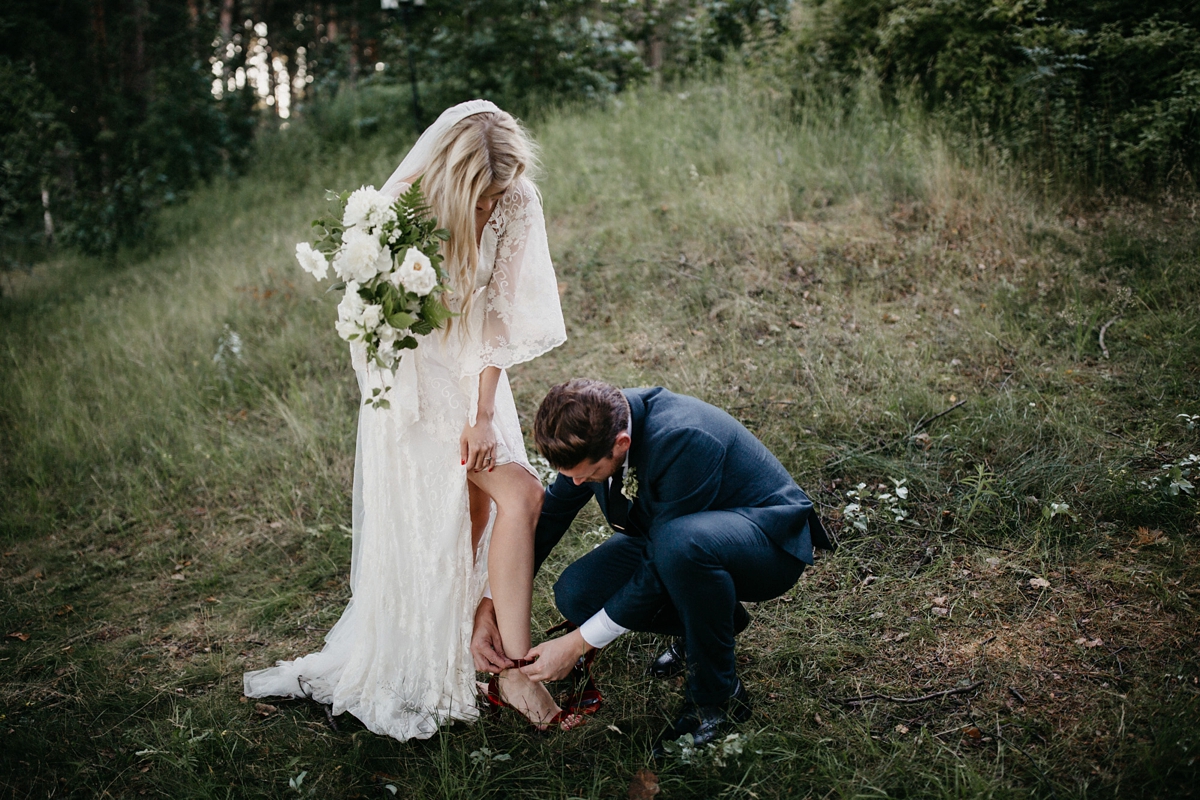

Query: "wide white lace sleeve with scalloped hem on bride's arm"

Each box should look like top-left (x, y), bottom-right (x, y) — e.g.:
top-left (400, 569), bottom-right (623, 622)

top-left (464, 178), bottom-right (566, 374)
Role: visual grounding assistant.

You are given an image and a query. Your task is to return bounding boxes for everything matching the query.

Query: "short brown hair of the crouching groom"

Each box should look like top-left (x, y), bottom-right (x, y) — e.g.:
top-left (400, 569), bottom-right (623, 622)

top-left (533, 378), bottom-right (629, 469)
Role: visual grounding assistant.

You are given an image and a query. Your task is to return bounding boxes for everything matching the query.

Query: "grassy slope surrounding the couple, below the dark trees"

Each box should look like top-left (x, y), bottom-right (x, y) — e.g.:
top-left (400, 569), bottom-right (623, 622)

top-left (0, 78), bottom-right (1200, 799)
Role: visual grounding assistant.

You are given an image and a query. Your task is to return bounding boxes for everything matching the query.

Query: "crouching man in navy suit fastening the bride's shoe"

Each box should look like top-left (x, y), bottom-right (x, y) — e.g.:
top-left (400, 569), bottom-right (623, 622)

top-left (472, 378), bottom-right (834, 753)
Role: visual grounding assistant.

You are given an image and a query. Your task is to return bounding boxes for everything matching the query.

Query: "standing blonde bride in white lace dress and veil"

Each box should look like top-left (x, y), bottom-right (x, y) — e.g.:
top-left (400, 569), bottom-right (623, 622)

top-left (244, 100), bottom-right (574, 740)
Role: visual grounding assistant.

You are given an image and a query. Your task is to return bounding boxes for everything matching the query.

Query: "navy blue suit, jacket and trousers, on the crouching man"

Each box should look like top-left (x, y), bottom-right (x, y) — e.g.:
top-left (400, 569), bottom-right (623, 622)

top-left (534, 387), bottom-right (834, 705)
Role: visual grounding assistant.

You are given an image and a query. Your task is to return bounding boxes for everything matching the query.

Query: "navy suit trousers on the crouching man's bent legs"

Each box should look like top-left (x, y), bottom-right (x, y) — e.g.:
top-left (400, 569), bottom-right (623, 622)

top-left (554, 511), bottom-right (804, 705)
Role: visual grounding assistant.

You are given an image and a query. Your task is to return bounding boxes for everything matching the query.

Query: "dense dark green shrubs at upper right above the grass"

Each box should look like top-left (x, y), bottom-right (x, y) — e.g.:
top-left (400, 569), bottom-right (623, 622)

top-left (799, 0), bottom-right (1200, 187)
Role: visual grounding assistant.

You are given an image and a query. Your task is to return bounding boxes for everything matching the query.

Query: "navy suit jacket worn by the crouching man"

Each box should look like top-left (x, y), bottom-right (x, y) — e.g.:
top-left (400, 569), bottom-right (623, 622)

top-left (534, 387), bottom-right (835, 566)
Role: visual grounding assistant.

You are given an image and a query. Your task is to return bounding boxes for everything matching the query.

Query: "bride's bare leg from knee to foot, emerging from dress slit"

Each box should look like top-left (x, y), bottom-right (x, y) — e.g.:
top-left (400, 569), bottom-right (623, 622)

top-left (468, 463), bottom-right (569, 727)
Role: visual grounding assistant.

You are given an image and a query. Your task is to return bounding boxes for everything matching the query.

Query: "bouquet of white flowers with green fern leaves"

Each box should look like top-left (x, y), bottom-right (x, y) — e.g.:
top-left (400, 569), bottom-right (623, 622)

top-left (296, 179), bottom-right (454, 408)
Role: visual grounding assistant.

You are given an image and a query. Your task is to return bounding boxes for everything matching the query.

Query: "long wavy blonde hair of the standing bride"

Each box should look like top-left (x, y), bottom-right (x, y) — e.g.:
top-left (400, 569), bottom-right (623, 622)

top-left (421, 112), bottom-right (536, 331)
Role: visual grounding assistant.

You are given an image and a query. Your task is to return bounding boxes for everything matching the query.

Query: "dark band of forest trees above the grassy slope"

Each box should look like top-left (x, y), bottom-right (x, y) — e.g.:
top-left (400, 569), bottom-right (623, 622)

top-left (7, 0), bottom-right (1200, 262)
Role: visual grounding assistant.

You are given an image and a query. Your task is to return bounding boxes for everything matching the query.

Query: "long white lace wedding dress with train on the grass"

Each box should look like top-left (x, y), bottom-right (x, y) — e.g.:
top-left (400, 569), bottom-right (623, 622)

top-left (244, 175), bottom-right (566, 740)
